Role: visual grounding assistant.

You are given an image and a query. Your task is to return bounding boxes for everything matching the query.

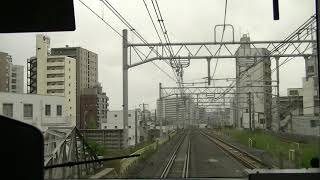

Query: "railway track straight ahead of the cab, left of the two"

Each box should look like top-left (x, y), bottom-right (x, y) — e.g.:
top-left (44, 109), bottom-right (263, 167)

top-left (160, 132), bottom-right (191, 178)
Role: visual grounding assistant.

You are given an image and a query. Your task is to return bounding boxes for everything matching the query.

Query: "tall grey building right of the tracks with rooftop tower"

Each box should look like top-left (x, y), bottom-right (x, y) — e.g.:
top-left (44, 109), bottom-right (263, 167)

top-left (235, 35), bottom-right (272, 129)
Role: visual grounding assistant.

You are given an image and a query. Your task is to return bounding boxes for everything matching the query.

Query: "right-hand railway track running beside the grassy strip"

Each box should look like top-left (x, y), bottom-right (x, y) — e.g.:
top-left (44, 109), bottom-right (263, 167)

top-left (200, 131), bottom-right (270, 169)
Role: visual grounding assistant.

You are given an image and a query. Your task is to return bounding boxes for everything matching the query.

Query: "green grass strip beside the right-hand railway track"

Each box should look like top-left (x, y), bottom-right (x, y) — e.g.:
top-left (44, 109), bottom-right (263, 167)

top-left (221, 129), bottom-right (318, 168)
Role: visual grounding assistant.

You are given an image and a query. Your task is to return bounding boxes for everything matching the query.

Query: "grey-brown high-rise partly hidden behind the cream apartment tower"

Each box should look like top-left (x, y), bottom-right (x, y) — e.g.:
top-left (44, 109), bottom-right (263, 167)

top-left (51, 46), bottom-right (98, 127)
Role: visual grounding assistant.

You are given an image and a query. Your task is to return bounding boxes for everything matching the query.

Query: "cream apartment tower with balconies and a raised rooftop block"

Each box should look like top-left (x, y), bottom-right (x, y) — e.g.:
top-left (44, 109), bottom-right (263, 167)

top-left (28, 35), bottom-right (76, 126)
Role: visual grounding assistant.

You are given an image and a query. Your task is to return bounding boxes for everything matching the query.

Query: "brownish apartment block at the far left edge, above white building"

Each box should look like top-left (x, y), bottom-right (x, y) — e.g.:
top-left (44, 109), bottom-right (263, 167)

top-left (0, 52), bottom-right (24, 93)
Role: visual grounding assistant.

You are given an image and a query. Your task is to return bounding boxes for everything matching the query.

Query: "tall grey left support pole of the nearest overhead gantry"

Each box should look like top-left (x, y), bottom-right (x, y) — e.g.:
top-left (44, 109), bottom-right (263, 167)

top-left (122, 29), bottom-right (129, 146)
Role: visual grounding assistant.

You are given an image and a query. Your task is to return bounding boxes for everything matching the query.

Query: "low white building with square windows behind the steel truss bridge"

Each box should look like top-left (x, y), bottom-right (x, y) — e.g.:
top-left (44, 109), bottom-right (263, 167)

top-left (0, 92), bottom-right (71, 131)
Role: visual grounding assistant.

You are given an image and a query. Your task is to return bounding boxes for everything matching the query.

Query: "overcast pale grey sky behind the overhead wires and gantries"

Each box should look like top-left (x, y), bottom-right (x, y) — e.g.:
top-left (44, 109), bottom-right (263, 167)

top-left (0, 0), bottom-right (315, 110)
